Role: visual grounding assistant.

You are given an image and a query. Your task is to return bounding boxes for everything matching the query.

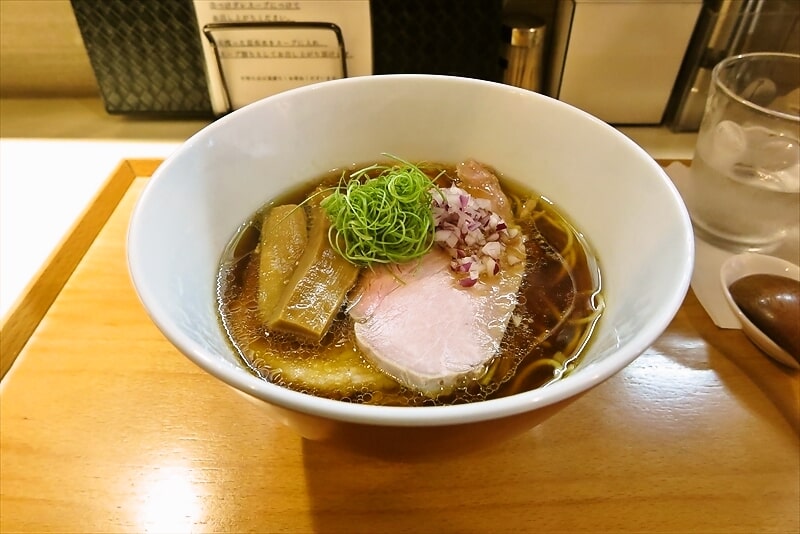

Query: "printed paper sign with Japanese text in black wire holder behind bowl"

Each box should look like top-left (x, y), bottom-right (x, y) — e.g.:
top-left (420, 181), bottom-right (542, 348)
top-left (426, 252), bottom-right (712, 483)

top-left (194, 0), bottom-right (372, 114)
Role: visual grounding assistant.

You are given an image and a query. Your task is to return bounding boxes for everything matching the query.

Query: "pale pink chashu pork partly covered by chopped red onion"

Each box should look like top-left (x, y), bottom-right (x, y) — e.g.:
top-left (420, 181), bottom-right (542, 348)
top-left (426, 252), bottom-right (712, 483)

top-left (350, 162), bottom-right (524, 395)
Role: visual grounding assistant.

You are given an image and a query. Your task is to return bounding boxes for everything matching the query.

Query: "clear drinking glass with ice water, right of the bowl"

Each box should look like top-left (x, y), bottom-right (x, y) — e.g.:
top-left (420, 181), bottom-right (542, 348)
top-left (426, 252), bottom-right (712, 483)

top-left (687, 53), bottom-right (800, 252)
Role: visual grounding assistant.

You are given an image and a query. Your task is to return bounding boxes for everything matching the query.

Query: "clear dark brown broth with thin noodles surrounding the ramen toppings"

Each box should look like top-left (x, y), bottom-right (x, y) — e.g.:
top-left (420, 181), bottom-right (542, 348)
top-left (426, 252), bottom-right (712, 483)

top-left (212, 165), bottom-right (602, 406)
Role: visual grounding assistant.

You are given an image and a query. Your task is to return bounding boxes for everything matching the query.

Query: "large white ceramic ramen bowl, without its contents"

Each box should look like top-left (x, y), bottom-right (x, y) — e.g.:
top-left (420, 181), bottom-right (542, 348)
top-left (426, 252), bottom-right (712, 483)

top-left (128, 75), bottom-right (694, 460)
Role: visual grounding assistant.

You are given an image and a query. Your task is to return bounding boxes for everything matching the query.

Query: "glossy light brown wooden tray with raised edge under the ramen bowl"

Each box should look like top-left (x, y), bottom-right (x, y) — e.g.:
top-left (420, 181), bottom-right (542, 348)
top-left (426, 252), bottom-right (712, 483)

top-left (0, 161), bottom-right (800, 534)
